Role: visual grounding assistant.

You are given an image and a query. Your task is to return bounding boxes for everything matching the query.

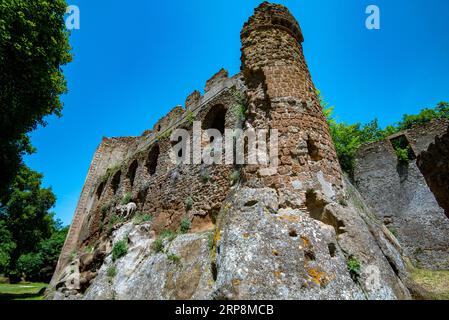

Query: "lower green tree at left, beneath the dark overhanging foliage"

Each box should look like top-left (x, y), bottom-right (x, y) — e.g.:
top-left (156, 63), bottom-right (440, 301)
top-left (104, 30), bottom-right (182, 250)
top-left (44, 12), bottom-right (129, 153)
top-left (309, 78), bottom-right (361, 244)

top-left (0, 165), bottom-right (67, 281)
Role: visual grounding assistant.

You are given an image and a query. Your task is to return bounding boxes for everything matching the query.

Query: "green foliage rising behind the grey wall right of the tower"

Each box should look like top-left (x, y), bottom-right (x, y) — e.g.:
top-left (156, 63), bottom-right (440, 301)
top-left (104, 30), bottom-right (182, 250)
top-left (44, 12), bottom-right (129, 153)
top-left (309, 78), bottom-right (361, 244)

top-left (318, 91), bottom-right (449, 177)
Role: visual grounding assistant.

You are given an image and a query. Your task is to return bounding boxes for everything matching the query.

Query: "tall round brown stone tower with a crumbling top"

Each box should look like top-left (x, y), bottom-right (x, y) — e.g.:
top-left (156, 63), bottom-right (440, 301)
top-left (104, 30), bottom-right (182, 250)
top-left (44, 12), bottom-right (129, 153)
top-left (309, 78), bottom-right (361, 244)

top-left (241, 2), bottom-right (342, 207)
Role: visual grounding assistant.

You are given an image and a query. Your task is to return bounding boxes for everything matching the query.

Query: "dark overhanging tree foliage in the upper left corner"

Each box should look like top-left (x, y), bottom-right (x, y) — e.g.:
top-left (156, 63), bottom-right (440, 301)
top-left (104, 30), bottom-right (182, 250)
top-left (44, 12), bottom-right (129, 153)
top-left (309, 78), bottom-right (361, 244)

top-left (0, 0), bottom-right (71, 198)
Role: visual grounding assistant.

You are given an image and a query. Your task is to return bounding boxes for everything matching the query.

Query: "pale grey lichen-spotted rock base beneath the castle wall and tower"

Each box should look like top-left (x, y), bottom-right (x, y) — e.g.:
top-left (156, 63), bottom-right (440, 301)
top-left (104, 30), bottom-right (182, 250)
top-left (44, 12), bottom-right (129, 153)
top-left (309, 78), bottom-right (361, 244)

top-left (48, 176), bottom-right (410, 300)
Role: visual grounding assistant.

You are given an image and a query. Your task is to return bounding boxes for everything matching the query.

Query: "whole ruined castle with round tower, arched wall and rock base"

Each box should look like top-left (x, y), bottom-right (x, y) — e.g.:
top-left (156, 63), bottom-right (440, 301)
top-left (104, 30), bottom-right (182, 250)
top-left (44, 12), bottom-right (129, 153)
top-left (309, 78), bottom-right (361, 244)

top-left (47, 2), bottom-right (446, 299)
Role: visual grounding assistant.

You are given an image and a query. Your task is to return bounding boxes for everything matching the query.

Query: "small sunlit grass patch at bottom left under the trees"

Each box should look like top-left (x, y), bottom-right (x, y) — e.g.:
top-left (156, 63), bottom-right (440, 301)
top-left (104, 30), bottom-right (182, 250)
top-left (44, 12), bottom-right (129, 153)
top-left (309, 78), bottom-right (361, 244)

top-left (0, 283), bottom-right (47, 300)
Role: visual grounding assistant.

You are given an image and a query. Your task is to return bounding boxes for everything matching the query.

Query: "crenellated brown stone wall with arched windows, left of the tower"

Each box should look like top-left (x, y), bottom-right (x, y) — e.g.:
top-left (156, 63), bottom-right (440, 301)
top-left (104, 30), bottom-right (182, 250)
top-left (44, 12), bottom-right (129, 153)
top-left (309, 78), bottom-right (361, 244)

top-left (55, 73), bottom-right (243, 282)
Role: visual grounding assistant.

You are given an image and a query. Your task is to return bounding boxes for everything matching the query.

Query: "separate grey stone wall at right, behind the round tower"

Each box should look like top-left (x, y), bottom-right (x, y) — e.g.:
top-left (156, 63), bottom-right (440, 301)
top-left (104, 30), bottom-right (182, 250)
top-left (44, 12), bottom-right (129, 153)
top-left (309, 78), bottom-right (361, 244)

top-left (355, 121), bottom-right (449, 269)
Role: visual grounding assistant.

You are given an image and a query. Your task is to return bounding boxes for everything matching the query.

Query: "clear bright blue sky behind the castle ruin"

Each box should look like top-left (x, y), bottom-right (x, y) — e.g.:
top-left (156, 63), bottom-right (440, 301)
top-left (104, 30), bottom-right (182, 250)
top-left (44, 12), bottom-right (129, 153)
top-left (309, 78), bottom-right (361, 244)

top-left (26, 0), bottom-right (449, 224)
